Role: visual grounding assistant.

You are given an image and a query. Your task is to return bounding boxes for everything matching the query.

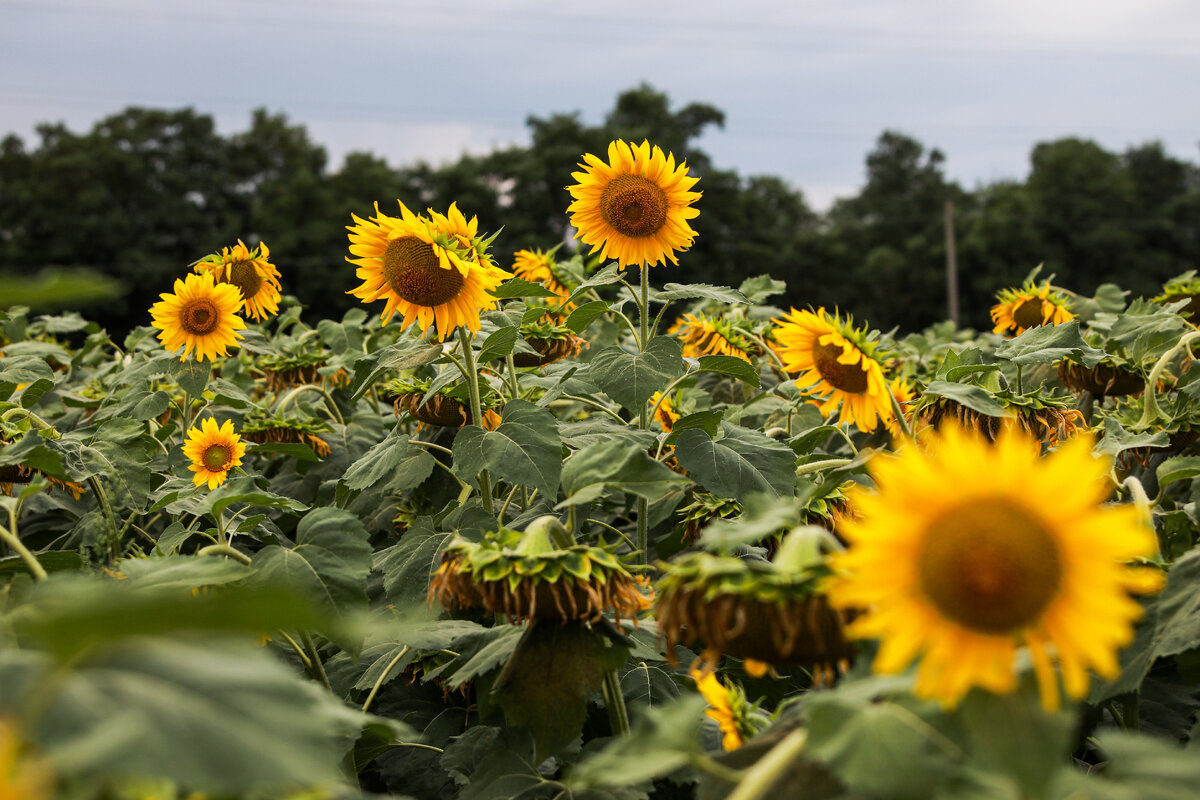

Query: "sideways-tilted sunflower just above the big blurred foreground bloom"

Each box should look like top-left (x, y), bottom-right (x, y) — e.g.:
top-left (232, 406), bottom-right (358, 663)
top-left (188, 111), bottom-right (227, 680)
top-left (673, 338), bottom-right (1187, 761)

top-left (774, 308), bottom-right (893, 431)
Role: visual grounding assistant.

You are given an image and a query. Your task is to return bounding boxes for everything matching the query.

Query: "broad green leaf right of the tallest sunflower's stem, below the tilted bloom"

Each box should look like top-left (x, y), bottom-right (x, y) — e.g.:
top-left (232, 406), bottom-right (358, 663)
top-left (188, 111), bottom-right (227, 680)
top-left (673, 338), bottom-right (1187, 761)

top-left (676, 422), bottom-right (796, 500)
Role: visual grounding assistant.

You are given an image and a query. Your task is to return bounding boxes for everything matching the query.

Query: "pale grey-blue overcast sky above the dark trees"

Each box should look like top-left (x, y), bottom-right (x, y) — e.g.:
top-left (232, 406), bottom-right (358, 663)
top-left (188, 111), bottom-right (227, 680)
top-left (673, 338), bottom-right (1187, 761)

top-left (0, 0), bottom-right (1200, 207)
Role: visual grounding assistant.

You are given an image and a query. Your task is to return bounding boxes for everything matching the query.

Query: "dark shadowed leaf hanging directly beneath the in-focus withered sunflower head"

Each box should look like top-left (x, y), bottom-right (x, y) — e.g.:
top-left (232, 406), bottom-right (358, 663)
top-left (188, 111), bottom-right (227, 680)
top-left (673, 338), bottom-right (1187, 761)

top-left (492, 619), bottom-right (629, 763)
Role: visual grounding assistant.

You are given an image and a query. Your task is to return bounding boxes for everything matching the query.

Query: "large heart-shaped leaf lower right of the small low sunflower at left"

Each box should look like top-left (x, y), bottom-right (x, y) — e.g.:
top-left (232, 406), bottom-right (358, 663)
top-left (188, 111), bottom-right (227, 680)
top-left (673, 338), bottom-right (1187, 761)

top-left (253, 506), bottom-right (372, 640)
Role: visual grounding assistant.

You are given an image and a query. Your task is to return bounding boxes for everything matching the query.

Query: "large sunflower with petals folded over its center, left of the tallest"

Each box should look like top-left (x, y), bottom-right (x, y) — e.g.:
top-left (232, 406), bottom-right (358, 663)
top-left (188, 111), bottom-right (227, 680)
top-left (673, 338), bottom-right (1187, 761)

top-left (346, 200), bottom-right (512, 342)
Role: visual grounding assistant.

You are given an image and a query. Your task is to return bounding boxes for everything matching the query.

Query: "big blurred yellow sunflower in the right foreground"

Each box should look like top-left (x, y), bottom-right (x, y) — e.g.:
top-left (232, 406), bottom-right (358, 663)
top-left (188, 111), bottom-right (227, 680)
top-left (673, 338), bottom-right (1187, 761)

top-left (829, 426), bottom-right (1163, 710)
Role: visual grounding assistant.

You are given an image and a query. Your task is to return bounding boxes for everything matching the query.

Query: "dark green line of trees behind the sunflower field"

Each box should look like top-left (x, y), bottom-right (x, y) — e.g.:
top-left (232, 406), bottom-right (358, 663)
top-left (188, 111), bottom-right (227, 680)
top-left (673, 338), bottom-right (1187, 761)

top-left (0, 84), bottom-right (1200, 332)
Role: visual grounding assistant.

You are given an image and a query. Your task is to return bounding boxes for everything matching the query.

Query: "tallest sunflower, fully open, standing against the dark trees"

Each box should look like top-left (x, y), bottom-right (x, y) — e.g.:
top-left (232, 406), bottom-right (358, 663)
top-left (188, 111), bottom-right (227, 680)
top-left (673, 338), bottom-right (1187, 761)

top-left (566, 139), bottom-right (701, 266)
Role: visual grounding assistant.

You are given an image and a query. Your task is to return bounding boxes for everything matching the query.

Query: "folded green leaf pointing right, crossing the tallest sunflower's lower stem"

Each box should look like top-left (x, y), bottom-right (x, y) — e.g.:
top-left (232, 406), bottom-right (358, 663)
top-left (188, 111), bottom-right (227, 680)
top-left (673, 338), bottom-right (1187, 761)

top-left (559, 440), bottom-right (691, 506)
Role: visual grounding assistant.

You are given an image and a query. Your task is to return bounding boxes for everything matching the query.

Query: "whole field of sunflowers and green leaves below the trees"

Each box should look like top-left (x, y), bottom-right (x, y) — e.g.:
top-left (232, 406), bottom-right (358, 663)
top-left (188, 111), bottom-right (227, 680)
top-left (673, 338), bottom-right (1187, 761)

top-left (0, 140), bottom-right (1200, 800)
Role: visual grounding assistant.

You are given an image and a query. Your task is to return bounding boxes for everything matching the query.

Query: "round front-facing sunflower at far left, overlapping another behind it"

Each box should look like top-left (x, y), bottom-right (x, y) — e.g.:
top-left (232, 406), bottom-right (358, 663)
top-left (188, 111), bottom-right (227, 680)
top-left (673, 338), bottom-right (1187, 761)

top-left (150, 275), bottom-right (246, 361)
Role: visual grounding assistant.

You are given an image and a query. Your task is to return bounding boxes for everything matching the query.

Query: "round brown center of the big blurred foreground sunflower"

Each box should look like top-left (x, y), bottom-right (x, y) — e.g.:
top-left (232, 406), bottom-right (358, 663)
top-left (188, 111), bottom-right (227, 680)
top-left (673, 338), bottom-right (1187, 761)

top-left (917, 500), bottom-right (1062, 634)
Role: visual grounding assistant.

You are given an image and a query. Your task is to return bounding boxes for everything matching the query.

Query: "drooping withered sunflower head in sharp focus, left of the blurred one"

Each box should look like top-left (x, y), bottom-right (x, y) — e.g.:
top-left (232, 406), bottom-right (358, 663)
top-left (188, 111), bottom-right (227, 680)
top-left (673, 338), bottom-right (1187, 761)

top-left (428, 522), bottom-right (654, 622)
